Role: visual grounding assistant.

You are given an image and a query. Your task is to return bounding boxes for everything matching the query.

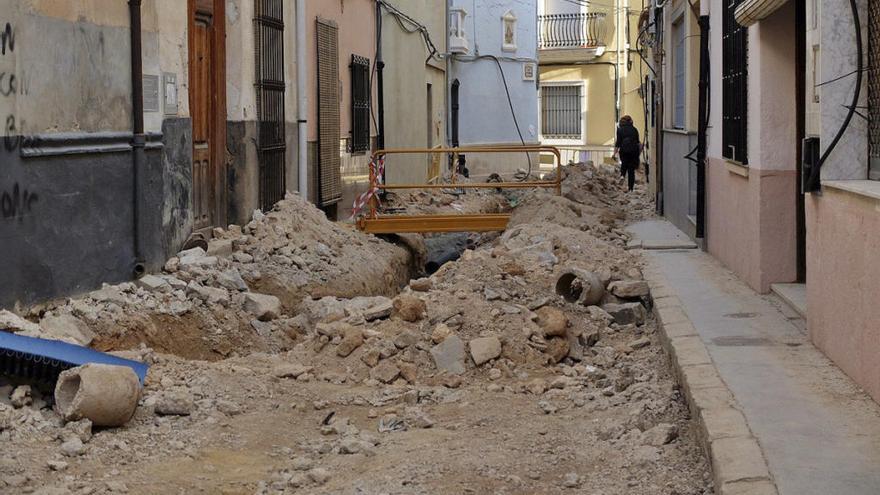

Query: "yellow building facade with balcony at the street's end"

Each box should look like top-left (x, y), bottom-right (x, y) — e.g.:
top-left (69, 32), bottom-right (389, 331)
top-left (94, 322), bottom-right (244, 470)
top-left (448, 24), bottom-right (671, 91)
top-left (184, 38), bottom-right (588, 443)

top-left (538, 0), bottom-right (650, 174)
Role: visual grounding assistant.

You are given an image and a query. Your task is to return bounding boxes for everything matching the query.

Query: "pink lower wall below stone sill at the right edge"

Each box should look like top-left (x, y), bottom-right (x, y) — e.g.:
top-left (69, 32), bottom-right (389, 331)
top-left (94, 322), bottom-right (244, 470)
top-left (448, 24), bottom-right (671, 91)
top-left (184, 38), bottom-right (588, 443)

top-left (806, 187), bottom-right (880, 402)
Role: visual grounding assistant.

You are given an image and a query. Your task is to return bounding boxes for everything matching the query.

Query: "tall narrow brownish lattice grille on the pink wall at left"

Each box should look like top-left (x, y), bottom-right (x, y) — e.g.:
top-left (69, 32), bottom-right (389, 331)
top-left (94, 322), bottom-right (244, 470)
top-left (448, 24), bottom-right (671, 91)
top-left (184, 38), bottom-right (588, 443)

top-left (315, 19), bottom-right (342, 206)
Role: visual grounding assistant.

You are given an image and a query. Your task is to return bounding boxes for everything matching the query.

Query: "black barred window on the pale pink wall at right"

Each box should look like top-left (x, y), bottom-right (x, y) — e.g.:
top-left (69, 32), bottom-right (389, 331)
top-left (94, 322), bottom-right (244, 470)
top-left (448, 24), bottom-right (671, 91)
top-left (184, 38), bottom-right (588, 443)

top-left (721, 0), bottom-right (749, 165)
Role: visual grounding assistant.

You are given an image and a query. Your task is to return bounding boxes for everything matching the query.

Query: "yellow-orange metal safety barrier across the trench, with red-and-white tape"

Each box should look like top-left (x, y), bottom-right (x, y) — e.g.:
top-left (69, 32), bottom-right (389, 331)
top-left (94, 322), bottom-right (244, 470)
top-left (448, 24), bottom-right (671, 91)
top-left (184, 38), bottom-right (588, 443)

top-left (353, 145), bottom-right (562, 234)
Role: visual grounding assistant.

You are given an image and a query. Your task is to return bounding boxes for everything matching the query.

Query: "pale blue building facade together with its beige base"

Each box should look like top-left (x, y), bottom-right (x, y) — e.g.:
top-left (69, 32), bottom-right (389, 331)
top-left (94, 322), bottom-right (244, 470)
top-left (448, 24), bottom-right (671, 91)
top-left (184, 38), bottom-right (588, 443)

top-left (448, 0), bottom-right (539, 176)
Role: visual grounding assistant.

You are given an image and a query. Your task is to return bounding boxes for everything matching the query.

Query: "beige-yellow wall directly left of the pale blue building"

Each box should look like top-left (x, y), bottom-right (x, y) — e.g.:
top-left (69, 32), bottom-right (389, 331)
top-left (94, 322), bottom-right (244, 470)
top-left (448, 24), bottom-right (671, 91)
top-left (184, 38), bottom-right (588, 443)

top-left (382, 0), bottom-right (446, 184)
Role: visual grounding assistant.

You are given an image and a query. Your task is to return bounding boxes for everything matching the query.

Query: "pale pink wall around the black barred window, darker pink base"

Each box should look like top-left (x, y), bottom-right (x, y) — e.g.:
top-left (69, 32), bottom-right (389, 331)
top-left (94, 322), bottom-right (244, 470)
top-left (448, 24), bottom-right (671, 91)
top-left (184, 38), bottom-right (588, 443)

top-left (706, 0), bottom-right (799, 293)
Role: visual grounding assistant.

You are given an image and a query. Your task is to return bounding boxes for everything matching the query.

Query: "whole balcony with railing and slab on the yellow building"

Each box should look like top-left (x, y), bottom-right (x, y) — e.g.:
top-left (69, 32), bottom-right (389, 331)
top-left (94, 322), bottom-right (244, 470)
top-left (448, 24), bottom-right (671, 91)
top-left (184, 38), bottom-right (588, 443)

top-left (538, 12), bottom-right (608, 62)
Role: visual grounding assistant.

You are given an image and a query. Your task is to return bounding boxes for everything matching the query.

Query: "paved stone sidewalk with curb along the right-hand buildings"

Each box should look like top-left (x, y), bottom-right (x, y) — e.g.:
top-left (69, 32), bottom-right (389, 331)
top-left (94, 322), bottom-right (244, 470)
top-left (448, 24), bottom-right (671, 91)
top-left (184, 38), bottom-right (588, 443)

top-left (630, 221), bottom-right (880, 495)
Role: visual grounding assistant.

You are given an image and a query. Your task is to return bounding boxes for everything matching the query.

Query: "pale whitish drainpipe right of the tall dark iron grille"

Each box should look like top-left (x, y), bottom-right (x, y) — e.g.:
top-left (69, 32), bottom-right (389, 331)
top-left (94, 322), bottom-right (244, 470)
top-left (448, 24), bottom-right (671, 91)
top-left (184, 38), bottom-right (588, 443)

top-left (296, 0), bottom-right (309, 201)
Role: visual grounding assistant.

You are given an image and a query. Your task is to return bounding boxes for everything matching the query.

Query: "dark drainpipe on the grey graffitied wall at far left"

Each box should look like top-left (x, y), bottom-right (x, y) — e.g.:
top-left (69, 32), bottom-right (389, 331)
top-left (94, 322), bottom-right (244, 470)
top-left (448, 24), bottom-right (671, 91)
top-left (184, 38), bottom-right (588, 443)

top-left (128, 0), bottom-right (147, 277)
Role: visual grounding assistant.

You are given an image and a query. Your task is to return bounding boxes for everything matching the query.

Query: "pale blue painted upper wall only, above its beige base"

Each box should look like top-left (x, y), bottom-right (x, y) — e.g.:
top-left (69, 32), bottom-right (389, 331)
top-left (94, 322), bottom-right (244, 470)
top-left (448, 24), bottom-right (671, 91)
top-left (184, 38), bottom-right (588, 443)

top-left (449, 0), bottom-right (539, 146)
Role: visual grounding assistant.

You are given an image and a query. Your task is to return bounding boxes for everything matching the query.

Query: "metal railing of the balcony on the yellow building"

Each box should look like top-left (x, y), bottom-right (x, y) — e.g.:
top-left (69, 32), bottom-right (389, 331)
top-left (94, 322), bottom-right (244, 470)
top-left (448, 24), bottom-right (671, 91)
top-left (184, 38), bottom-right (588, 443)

top-left (538, 12), bottom-right (608, 50)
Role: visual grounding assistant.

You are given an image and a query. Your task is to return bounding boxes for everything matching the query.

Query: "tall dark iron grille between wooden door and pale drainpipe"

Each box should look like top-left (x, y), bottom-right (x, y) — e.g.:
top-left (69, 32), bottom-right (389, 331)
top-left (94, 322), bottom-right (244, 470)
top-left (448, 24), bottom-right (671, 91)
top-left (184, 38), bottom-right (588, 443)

top-left (254, 0), bottom-right (287, 211)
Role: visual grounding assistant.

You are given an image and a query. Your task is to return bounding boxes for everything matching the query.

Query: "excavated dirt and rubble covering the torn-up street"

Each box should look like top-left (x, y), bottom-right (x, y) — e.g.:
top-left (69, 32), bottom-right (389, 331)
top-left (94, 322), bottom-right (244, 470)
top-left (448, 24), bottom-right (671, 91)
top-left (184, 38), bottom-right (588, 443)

top-left (0, 165), bottom-right (712, 495)
